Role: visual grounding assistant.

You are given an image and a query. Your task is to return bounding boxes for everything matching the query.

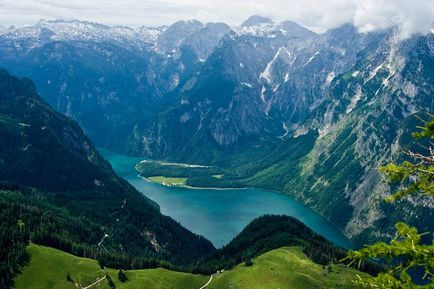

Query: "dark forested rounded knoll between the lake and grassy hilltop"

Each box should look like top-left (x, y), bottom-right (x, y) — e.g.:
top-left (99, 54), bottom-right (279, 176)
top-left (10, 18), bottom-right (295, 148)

top-left (195, 215), bottom-right (345, 274)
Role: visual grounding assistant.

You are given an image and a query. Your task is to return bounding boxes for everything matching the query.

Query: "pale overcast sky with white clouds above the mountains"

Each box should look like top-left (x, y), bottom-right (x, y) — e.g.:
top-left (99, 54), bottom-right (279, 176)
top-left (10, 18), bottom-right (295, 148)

top-left (0, 0), bottom-right (434, 38)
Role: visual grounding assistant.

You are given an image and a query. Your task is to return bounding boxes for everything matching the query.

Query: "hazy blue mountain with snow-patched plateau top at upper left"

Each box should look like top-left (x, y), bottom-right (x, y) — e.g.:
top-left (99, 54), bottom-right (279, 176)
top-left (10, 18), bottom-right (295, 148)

top-left (0, 20), bottom-right (229, 151)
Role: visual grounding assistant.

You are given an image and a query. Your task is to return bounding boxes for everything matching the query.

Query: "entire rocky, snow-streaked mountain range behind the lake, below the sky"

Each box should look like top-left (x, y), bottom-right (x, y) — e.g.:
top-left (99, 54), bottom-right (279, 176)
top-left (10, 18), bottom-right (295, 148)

top-left (0, 16), bottom-right (434, 243)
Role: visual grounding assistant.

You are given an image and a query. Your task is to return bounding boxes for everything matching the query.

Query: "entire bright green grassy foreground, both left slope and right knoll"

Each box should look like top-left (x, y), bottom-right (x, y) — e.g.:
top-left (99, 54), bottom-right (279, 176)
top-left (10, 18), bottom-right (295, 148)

top-left (15, 244), bottom-right (366, 289)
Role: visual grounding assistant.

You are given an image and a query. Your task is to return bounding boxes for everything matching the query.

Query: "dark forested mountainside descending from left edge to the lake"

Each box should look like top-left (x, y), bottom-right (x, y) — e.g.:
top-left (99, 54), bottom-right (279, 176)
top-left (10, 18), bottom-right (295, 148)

top-left (0, 70), bottom-right (215, 284)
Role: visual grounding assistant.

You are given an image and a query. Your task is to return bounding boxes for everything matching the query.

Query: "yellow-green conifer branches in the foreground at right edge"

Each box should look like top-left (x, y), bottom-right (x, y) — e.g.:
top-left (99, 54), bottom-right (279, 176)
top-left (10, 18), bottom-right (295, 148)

top-left (344, 115), bottom-right (434, 289)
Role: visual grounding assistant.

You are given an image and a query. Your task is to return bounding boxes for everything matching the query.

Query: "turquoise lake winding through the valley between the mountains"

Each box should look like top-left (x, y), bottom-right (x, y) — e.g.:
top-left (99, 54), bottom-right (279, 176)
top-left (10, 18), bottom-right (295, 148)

top-left (99, 149), bottom-right (351, 248)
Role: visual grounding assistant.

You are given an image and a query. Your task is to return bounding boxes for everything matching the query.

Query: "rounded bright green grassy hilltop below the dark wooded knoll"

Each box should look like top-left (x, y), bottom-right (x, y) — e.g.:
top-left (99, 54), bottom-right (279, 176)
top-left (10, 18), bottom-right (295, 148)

top-left (208, 247), bottom-right (363, 289)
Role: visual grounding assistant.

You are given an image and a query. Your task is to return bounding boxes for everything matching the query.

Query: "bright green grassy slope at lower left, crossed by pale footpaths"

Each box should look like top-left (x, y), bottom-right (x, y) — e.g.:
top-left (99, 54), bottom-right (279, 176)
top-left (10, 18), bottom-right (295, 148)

top-left (14, 244), bottom-right (209, 289)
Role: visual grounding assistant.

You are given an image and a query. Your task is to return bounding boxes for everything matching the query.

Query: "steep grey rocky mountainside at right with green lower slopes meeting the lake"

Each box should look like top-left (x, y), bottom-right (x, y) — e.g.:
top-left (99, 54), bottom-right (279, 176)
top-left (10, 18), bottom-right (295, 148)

top-left (217, 32), bottom-right (434, 243)
